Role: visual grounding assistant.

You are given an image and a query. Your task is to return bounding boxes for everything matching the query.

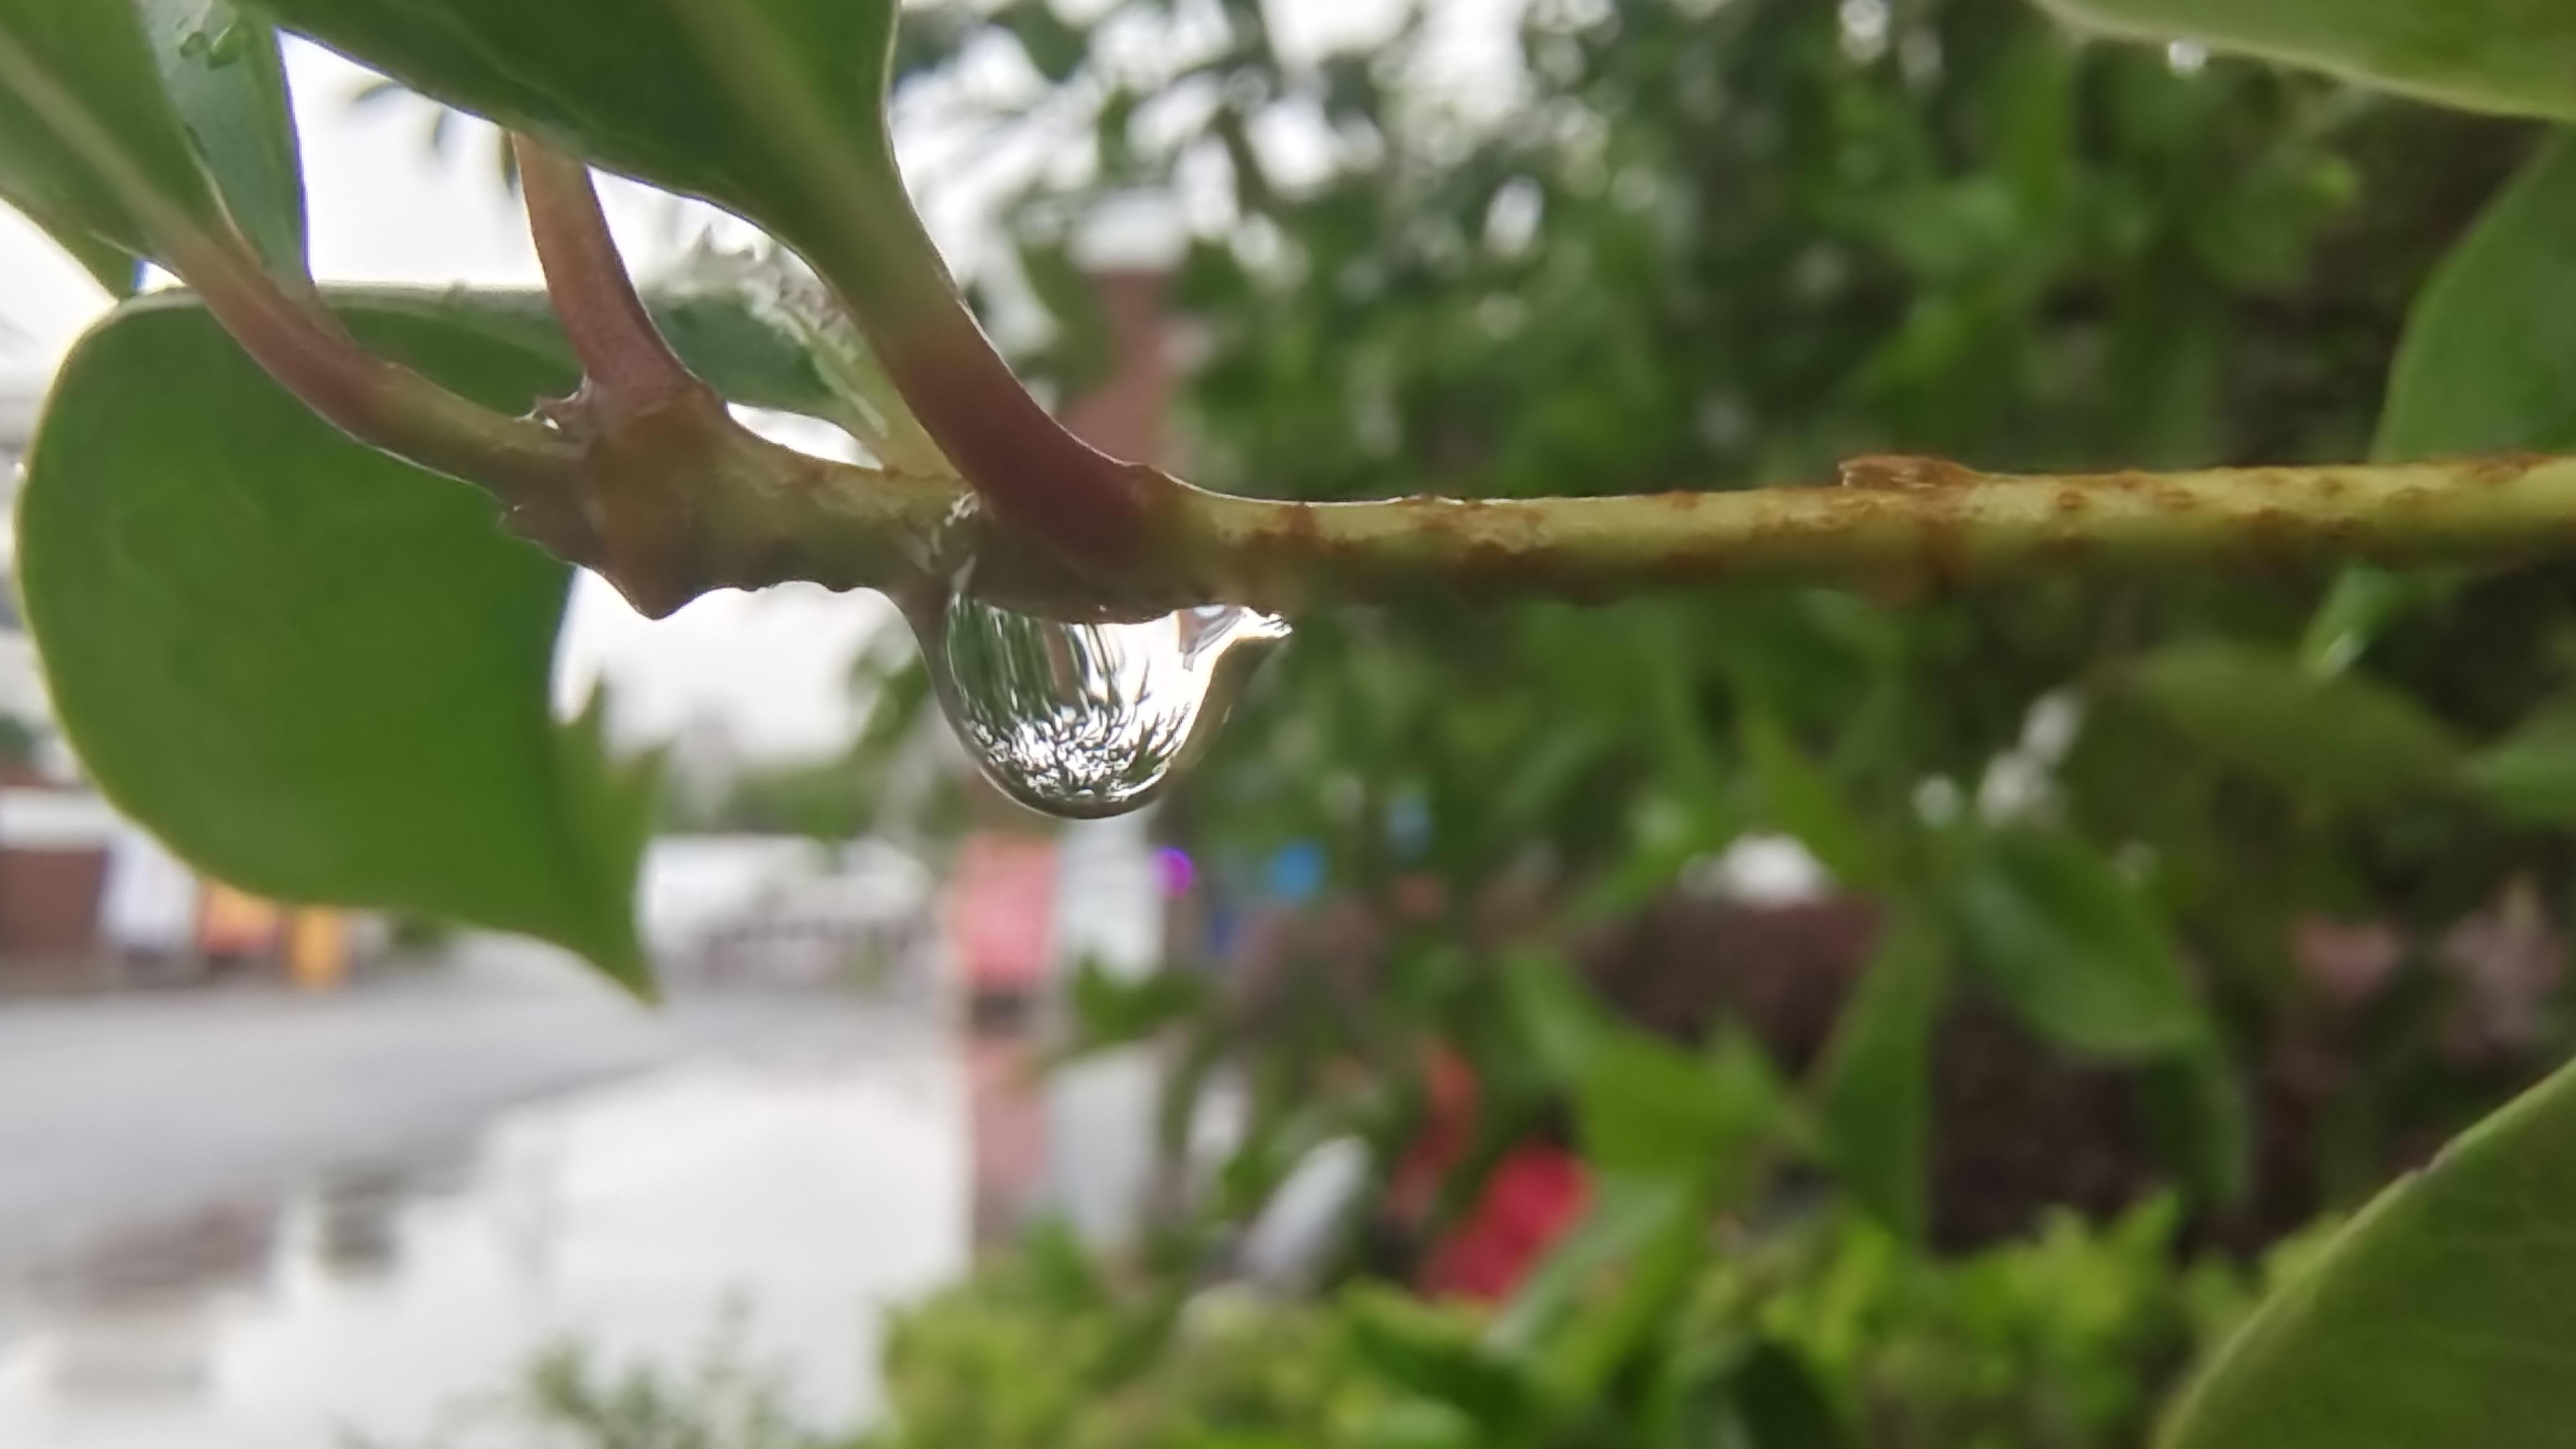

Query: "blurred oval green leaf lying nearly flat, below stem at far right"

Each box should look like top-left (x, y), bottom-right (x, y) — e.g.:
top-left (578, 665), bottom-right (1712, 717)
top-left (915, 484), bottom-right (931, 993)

top-left (2130, 642), bottom-right (2460, 804)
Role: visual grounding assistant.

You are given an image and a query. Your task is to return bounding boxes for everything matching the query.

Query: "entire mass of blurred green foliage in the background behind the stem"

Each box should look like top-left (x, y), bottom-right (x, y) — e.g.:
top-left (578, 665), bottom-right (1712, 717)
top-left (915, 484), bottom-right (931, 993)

top-left (824, 0), bottom-right (2576, 1447)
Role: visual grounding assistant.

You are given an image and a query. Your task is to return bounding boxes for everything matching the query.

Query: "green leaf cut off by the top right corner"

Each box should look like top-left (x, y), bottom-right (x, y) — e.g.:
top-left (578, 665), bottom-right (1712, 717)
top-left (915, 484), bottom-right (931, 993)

top-left (2040, 0), bottom-right (2576, 119)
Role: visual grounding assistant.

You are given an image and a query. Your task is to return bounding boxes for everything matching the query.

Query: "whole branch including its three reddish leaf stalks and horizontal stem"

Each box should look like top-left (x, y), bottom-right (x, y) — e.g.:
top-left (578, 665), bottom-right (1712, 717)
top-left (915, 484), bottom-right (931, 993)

top-left (0, 11), bottom-right (2576, 619)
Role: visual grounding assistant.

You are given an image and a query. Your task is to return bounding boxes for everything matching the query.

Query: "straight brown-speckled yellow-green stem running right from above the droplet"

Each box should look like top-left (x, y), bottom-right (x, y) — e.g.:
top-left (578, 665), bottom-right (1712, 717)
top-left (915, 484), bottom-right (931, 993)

top-left (1177, 456), bottom-right (2576, 611)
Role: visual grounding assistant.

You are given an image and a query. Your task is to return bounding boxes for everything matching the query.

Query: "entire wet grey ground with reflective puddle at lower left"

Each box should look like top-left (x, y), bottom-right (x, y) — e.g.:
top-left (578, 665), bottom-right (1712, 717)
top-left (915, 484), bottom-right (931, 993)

top-left (0, 959), bottom-right (968, 1449)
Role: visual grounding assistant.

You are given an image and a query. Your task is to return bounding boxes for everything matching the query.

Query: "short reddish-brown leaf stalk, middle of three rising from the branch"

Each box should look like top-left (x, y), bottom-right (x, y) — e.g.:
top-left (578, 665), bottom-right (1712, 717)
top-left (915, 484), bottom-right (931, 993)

top-left (510, 134), bottom-right (706, 428)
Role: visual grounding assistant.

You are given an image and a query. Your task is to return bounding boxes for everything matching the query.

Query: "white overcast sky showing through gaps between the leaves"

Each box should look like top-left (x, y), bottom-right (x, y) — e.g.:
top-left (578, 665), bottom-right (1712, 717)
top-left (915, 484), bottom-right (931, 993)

top-left (0, 0), bottom-right (1520, 755)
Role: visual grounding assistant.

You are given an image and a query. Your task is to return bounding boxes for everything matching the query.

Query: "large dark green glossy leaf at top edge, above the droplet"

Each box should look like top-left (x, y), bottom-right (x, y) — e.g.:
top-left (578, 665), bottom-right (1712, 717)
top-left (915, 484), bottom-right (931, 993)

top-left (246, 0), bottom-right (909, 254)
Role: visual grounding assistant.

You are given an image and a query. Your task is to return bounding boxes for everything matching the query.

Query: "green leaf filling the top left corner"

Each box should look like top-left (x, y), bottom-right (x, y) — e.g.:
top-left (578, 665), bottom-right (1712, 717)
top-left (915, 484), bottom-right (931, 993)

top-left (0, 0), bottom-right (224, 282)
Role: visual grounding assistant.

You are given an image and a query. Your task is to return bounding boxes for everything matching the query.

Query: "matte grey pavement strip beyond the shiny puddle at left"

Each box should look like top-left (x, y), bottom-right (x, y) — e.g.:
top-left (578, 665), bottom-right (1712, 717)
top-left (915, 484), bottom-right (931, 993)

top-left (0, 939), bottom-right (920, 1271)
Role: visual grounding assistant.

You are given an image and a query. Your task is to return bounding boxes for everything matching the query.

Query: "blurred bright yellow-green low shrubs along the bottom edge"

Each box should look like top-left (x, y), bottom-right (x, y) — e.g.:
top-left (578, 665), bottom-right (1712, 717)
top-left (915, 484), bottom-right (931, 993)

top-left (834, 1199), bottom-right (2313, 1449)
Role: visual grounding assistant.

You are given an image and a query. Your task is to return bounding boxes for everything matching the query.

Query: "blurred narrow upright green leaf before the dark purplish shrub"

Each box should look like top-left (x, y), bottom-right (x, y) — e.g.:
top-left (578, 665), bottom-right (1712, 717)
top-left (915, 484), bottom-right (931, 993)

top-left (1816, 908), bottom-right (1950, 1240)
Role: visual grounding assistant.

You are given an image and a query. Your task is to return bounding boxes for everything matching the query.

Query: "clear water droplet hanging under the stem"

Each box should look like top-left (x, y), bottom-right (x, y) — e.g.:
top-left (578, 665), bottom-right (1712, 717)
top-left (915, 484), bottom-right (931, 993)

top-left (912, 593), bottom-right (1288, 820)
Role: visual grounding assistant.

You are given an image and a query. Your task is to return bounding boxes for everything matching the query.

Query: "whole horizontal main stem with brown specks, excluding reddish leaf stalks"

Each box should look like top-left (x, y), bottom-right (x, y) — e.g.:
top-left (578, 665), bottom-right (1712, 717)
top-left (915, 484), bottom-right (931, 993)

top-left (695, 446), bottom-right (2576, 619)
